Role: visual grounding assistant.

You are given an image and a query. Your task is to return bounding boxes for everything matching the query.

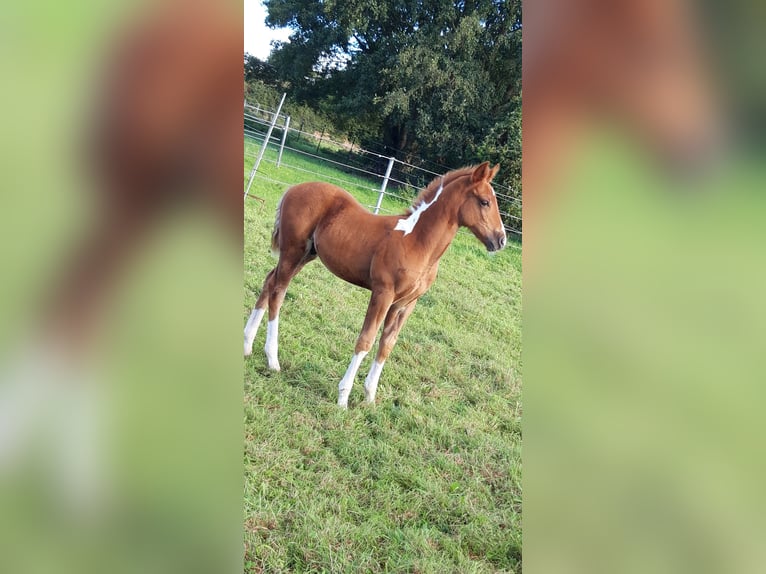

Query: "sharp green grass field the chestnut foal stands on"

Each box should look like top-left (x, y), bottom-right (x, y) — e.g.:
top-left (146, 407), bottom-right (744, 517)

top-left (242, 137), bottom-right (522, 573)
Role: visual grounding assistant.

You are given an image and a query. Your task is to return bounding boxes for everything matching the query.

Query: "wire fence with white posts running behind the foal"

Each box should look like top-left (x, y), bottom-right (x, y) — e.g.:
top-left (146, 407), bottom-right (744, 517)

top-left (244, 102), bottom-right (522, 245)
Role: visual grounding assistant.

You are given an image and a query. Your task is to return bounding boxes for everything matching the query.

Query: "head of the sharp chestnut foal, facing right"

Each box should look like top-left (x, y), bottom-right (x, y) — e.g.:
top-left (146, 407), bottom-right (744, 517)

top-left (458, 162), bottom-right (506, 251)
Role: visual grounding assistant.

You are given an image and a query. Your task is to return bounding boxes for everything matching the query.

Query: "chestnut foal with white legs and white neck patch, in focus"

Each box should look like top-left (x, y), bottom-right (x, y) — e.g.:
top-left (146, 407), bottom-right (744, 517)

top-left (245, 162), bottom-right (506, 408)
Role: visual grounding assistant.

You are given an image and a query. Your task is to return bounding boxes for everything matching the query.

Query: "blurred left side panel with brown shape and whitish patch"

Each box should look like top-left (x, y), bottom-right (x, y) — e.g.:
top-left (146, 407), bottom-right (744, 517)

top-left (0, 0), bottom-right (242, 573)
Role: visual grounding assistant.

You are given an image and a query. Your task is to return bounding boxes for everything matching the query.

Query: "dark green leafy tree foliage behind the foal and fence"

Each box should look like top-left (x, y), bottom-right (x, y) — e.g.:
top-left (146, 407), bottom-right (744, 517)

top-left (265, 0), bottom-right (521, 184)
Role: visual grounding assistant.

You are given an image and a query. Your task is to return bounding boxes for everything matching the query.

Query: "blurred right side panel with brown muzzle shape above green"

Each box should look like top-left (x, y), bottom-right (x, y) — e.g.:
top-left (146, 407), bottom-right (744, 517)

top-left (524, 0), bottom-right (766, 574)
